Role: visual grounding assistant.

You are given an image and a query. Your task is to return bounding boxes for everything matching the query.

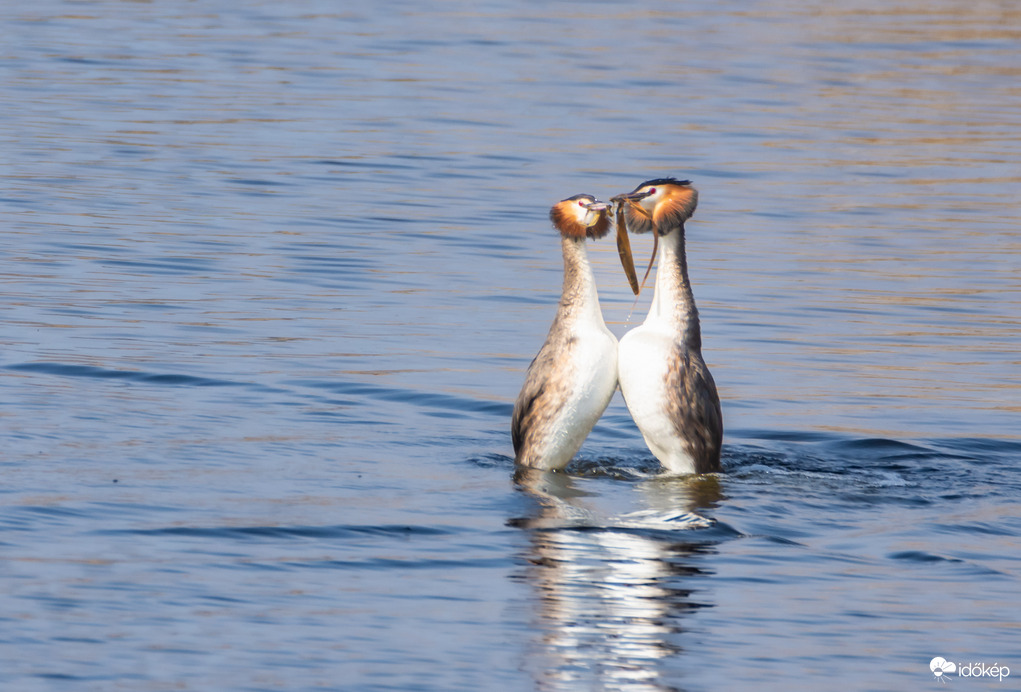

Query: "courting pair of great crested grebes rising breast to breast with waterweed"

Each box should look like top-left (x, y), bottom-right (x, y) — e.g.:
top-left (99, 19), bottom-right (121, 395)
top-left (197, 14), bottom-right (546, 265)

top-left (511, 178), bottom-right (723, 474)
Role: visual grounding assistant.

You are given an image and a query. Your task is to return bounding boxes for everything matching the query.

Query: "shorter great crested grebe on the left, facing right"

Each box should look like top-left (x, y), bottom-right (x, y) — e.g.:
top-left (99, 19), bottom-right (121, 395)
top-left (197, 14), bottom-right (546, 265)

top-left (511, 195), bottom-right (617, 471)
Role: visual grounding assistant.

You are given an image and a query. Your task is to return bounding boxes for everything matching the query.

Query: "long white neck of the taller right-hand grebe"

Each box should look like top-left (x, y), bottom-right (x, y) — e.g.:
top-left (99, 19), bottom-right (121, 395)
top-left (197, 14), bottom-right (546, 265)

top-left (645, 226), bottom-right (701, 350)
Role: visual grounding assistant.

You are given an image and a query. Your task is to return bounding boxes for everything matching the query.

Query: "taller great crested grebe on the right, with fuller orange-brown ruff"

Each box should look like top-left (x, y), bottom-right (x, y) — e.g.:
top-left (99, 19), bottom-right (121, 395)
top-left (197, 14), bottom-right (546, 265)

top-left (613, 178), bottom-right (723, 474)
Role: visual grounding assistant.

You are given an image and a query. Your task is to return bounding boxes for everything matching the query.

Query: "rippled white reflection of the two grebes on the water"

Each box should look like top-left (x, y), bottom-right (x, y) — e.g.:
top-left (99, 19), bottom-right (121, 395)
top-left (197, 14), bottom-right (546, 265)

top-left (511, 468), bottom-right (722, 692)
